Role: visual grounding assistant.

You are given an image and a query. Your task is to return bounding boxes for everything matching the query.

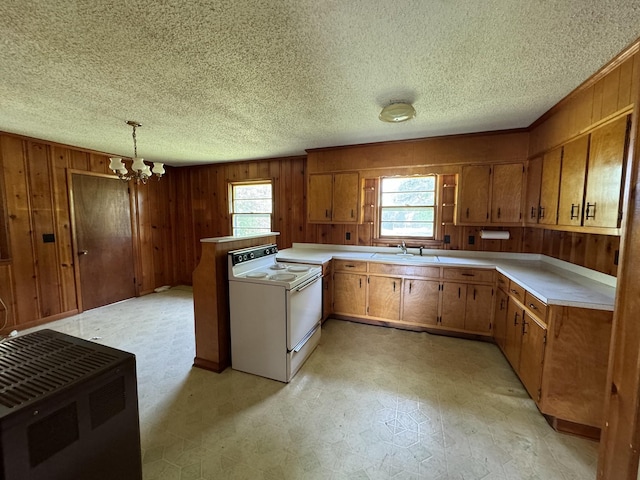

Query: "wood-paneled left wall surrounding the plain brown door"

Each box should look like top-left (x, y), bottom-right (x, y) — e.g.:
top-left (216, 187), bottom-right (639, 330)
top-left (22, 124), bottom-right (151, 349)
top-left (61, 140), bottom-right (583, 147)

top-left (0, 134), bottom-right (176, 333)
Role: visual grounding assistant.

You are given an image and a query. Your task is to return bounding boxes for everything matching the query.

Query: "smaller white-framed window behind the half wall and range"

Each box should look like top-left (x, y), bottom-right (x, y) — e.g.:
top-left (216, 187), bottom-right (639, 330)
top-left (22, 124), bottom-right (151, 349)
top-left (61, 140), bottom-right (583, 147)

top-left (229, 181), bottom-right (273, 237)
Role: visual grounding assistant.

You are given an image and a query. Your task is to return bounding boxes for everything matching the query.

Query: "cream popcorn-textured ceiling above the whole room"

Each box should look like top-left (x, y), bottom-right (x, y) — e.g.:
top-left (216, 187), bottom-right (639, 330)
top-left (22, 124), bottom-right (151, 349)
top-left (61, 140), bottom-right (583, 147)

top-left (0, 0), bottom-right (640, 165)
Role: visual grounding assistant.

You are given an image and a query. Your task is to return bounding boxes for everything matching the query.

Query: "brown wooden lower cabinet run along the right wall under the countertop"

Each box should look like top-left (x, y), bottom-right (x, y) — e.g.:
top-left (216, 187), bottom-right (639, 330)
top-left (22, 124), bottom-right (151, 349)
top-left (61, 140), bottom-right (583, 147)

top-left (494, 276), bottom-right (613, 438)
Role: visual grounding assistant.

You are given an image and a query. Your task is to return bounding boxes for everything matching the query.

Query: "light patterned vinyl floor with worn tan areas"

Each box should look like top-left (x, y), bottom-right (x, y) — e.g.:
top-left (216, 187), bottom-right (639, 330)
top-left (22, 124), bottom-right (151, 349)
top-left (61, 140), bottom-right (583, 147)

top-left (22, 287), bottom-right (598, 480)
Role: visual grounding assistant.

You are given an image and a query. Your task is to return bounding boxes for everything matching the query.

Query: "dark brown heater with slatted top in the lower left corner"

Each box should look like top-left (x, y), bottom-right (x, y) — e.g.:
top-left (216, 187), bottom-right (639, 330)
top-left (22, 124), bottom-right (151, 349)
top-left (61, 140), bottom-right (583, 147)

top-left (0, 330), bottom-right (142, 480)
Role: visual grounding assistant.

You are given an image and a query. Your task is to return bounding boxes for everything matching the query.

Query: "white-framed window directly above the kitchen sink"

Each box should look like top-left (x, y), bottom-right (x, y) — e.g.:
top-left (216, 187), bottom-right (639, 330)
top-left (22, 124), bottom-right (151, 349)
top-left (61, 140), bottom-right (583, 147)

top-left (379, 175), bottom-right (438, 239)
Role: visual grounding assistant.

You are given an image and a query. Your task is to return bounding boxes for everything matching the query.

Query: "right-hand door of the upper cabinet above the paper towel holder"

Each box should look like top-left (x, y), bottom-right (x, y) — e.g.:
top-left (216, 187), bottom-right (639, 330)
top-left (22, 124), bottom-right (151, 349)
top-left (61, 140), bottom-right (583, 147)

top-left (491, 163), bottom-right (524, 223)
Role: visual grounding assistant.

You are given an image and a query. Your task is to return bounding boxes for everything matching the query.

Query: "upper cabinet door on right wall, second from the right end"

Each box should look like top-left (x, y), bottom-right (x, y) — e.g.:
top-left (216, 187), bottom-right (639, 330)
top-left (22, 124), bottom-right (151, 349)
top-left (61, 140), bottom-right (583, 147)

top-left (558, 135), bottom-right (589, 226)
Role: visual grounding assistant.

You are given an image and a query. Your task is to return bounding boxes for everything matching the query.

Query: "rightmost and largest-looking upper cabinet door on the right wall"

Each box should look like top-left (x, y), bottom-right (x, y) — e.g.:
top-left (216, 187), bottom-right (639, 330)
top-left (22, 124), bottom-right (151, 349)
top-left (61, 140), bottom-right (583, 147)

top-left (583, 117), bottom-right (627, 228)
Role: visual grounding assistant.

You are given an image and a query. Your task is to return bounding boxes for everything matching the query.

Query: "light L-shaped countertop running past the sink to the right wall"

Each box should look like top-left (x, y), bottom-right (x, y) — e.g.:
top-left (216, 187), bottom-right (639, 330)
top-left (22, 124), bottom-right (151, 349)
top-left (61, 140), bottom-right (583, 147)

top-left (278, 243), bottom-right (616, 311)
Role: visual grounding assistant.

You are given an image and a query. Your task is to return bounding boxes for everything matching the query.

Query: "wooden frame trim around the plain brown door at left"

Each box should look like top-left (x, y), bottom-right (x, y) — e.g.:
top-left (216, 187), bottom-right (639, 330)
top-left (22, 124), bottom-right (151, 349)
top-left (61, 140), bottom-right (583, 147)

top-left (67, 168), bottom-right (141, 313)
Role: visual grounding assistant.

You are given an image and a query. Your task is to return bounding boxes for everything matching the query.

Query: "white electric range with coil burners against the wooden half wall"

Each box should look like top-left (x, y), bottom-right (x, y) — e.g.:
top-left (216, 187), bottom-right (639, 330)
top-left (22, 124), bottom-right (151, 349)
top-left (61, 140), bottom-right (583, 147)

top-left (228, 244), bottom-right (322, 382)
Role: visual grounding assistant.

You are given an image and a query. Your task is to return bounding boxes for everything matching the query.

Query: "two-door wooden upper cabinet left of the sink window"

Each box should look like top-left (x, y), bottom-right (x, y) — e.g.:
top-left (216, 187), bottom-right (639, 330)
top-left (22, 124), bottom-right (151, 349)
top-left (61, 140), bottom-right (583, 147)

top-left (307, 172), bottom-right (360, 223)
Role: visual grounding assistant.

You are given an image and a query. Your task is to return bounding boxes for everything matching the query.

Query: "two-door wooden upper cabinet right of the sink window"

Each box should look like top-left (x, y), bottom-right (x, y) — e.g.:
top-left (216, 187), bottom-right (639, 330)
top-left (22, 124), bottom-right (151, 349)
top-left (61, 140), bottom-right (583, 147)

top-left (458, 163), bottom-right (524, 225)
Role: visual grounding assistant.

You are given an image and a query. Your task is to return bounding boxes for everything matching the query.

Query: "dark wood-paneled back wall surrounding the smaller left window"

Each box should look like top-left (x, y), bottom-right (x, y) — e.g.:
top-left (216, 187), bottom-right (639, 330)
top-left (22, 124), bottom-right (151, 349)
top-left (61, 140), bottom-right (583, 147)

top-left (172, 157), bottom-right (307, 284)
